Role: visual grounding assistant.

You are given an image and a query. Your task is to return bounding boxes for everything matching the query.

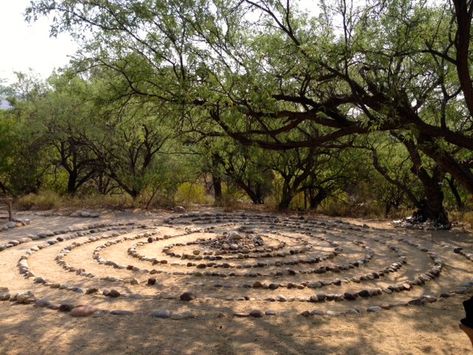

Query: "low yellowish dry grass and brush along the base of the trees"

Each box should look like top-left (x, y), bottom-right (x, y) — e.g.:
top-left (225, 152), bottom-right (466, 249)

top-left (15, 191), bottom-right (473, 230)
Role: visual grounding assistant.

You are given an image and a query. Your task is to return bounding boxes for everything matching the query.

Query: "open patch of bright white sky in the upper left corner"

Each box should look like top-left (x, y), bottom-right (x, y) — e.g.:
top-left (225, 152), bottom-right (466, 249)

top-left (0, 0), bottom-right (77, 84)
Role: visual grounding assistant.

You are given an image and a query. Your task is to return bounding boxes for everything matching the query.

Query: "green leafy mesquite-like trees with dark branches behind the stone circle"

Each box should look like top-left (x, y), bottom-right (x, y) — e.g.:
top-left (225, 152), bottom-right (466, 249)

top-left (0, 0), bottom-right (473, 225)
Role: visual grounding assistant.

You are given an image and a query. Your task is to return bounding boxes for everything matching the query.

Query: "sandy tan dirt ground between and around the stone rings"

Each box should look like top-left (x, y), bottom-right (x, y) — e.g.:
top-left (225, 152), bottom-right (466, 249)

top-left (0, 210), bottom-right (473, 354)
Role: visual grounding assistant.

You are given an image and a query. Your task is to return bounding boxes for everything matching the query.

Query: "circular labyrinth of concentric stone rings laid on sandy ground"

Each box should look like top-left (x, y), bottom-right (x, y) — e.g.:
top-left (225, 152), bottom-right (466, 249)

top-left (0, 213), bottom-right (473, 319)
